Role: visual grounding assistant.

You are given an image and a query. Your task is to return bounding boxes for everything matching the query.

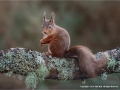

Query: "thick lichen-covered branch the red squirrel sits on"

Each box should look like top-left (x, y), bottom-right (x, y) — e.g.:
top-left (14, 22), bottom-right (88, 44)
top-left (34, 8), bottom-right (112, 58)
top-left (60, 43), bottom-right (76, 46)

top-left (0, 48), bottom-right (120, 88)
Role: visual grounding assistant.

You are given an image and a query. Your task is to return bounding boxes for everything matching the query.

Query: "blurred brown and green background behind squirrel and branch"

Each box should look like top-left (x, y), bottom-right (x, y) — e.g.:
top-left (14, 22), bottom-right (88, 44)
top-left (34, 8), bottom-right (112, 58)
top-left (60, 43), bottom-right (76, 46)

top-left (0, 1), bottom-right (120, 90)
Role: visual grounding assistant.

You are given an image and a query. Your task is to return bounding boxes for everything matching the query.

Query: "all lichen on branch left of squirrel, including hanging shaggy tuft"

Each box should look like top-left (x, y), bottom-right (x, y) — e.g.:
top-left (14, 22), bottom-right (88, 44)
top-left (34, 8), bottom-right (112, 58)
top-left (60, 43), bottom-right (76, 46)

top-left (0, 48), bottom-right (49, 89)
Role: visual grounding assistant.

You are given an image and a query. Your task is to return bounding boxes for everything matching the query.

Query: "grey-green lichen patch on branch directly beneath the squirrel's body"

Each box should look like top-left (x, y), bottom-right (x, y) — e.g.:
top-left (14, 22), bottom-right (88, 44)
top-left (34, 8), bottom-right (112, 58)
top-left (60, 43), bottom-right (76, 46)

top-left (48, 56), bottom-right (78, 80)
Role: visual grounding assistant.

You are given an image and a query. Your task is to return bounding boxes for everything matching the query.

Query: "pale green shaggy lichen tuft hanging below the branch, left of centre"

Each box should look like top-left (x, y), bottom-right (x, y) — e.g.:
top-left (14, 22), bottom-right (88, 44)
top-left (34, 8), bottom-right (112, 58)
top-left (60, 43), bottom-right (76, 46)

top-left (25, 63), bottom-right (49, 89)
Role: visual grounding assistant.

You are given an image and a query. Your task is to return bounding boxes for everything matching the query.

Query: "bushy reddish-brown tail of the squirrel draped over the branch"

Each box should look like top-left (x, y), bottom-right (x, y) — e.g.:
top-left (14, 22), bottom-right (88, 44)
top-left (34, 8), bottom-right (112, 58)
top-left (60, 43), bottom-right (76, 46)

top-left (66, 45), bottom-right (108, 77)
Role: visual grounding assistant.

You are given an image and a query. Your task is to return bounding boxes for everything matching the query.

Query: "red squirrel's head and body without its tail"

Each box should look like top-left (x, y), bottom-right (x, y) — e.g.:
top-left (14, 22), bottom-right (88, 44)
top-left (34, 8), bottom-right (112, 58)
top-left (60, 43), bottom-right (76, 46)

top-left (40, 13), bottom-right (70, 58)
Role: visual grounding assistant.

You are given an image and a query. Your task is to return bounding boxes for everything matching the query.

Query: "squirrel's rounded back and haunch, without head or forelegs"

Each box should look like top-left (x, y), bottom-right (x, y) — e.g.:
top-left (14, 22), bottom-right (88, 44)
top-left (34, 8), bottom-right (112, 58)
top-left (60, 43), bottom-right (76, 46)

top-left (49, 25), bottom-right (70, 58)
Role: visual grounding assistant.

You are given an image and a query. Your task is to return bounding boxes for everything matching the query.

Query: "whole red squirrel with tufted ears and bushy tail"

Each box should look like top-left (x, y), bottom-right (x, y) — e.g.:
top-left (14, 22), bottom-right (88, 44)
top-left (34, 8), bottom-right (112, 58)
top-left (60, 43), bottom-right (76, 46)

top-left (40, 12), bottom-right (108, 77)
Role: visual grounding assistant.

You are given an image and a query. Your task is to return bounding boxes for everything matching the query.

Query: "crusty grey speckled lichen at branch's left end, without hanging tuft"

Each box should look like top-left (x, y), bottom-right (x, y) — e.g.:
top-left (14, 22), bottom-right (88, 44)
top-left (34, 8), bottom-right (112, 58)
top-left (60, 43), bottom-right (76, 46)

top-left (0, 48), bottom-right (40, 75)
